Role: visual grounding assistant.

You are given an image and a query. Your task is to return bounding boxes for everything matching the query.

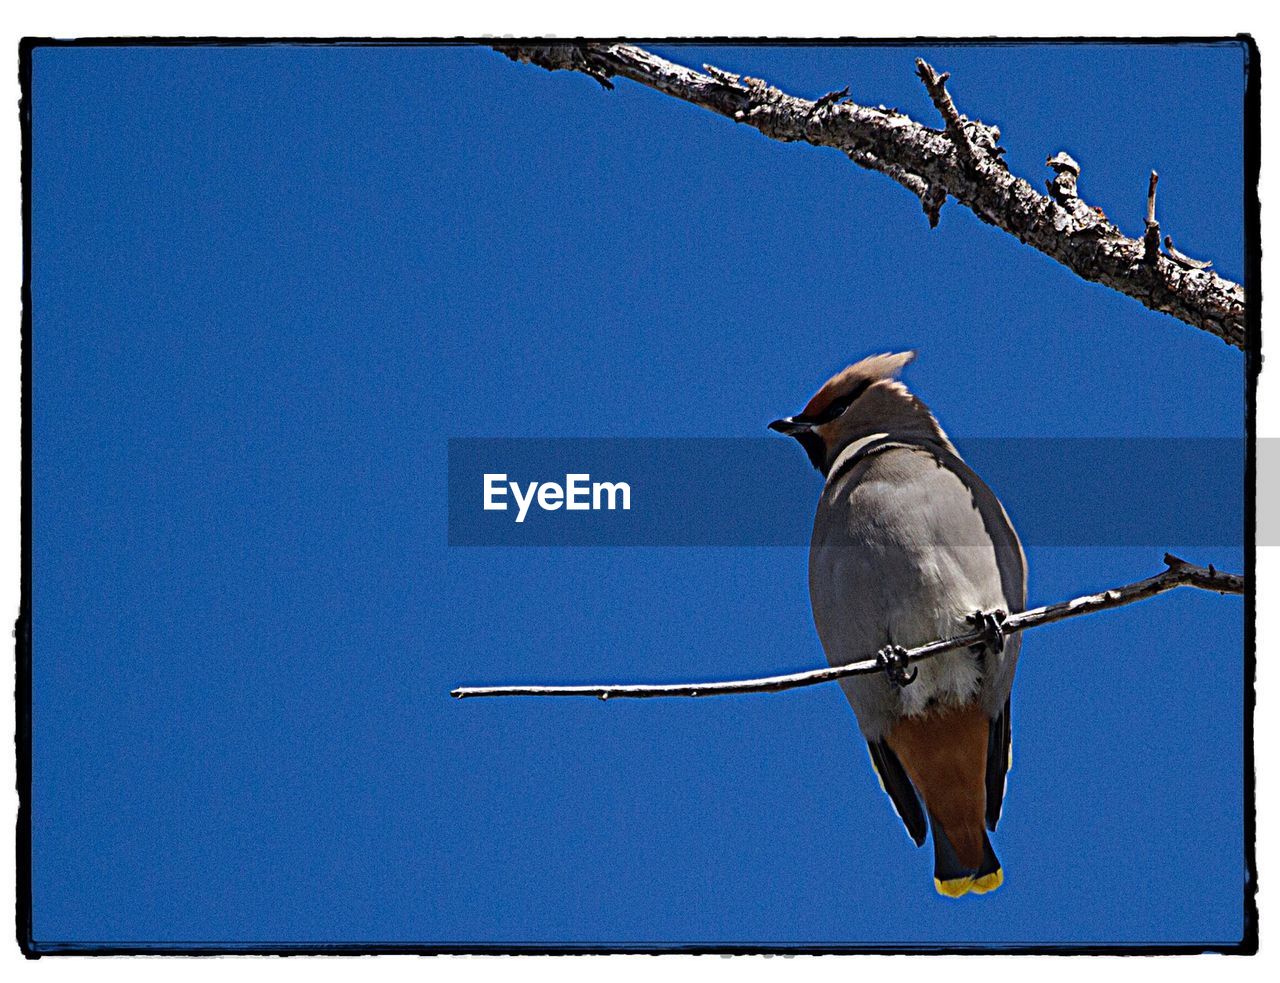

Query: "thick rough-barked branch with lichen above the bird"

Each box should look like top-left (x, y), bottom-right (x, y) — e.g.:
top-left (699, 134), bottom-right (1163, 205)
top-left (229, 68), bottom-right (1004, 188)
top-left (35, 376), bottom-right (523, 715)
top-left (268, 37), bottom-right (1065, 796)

top-left (494, 44), bottom-right (1245, 348)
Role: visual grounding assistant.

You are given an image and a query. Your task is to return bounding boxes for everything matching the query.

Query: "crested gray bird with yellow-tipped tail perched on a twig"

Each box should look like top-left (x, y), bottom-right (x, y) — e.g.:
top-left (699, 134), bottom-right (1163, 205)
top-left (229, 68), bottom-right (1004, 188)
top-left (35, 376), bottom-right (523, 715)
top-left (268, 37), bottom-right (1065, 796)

top-left (769, 352), bottom-right (1027, 897)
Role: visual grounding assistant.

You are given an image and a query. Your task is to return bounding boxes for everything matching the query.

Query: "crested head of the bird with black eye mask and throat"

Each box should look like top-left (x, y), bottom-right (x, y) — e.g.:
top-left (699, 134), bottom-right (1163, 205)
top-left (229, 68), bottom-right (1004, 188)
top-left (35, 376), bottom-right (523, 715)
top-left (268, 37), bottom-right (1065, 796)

top-left (769, 352), bottom-right (946, 475)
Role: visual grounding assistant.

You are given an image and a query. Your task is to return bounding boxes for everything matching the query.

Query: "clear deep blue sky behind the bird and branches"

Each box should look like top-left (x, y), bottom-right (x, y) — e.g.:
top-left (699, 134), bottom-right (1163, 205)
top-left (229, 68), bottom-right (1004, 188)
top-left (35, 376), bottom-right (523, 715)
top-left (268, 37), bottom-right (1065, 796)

top-left (32, 45), bottom-right (1244, 946)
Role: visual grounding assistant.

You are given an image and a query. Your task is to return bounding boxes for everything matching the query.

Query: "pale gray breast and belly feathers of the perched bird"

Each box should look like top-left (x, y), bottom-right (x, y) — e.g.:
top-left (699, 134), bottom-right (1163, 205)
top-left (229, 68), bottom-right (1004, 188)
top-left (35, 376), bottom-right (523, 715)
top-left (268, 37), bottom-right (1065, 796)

top-left (809, 440), bottom-right (1027, 740)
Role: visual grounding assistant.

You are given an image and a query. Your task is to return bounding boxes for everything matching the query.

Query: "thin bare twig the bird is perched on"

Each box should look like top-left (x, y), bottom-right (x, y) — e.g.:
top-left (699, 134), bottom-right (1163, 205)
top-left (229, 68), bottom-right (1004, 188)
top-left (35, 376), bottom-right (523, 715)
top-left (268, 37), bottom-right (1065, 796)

top-left (452, 553), bottom-right (1244, 700)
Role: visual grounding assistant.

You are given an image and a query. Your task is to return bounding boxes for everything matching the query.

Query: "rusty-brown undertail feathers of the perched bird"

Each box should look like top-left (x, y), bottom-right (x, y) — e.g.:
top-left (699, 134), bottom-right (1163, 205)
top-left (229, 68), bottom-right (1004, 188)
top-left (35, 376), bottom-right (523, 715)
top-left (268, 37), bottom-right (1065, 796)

top-left (888, 703), bottom-right (991, 869)
